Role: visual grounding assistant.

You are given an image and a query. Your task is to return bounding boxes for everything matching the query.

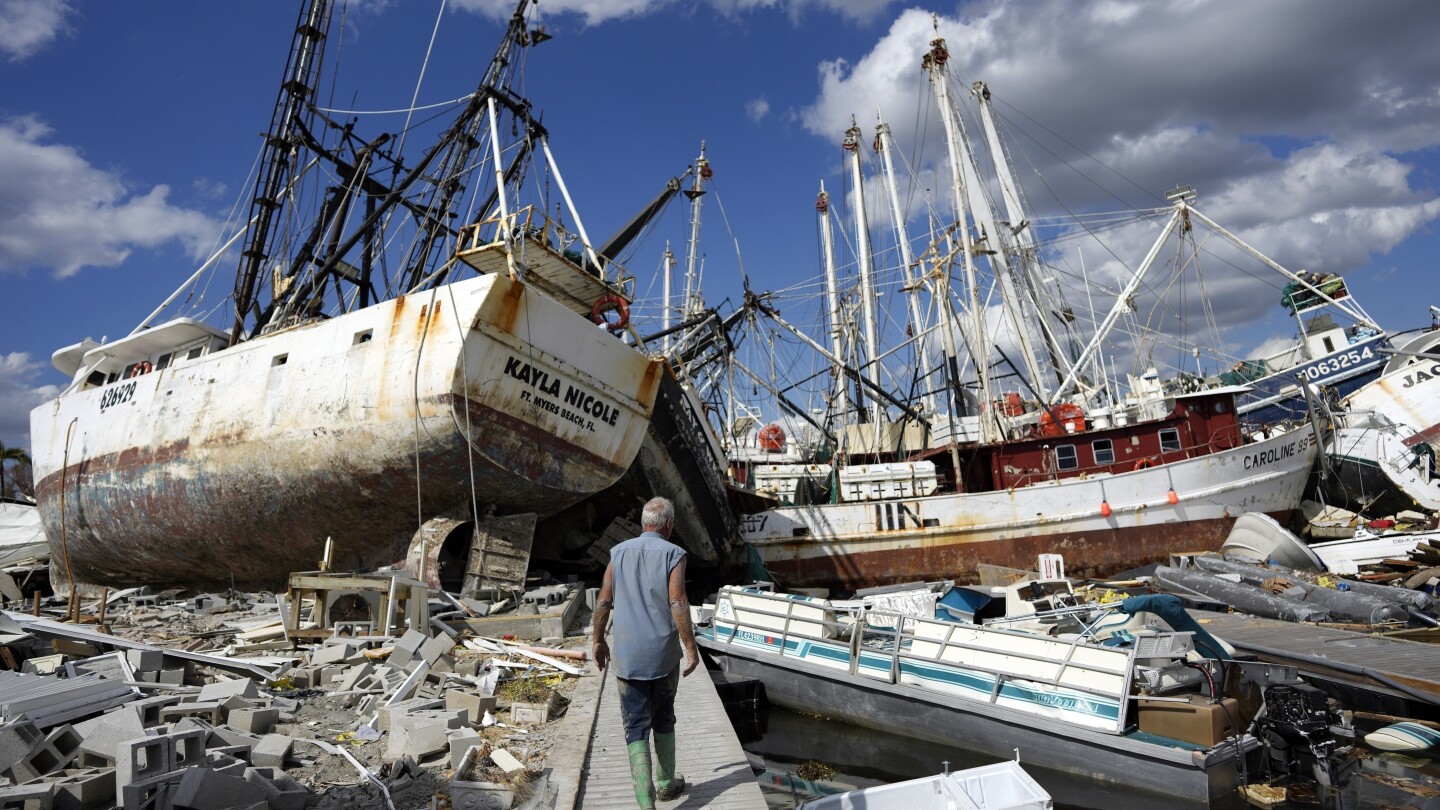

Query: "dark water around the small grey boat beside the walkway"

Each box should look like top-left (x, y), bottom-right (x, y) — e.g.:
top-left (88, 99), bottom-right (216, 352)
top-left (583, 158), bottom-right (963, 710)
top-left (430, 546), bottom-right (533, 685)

top-left (727, 680), bottom-right (1440, 810)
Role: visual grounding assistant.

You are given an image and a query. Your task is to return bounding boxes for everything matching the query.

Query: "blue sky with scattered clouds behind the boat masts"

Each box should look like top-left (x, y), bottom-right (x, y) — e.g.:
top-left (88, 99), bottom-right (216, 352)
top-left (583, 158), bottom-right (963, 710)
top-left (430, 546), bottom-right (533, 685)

top-left (0, 0), bottom-right (1440, 447)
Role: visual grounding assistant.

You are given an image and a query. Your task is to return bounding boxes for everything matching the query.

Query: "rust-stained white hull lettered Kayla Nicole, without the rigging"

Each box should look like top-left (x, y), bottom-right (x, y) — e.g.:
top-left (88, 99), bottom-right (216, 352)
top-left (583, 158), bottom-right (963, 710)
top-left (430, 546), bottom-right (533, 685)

top-left (32, 275), bottom-right (658, 585)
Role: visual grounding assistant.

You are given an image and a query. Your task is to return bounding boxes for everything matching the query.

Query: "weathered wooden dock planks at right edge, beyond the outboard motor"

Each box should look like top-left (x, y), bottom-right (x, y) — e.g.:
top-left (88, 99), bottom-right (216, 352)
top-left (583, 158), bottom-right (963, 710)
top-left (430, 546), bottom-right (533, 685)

top-left (1191, 610), bottom-right (1440, 698)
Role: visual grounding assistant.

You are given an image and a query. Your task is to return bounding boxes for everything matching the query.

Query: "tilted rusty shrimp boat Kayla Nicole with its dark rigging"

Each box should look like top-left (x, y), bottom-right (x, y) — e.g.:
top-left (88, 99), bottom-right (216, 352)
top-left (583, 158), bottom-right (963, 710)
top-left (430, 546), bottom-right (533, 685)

top-left (32, 0), bottom-right (733, 585)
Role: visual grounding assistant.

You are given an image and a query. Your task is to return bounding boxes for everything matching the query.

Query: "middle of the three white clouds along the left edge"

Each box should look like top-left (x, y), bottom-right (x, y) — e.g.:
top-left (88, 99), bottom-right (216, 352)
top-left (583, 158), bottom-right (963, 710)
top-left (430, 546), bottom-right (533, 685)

top-left (0, 117), bottom-right (219, 278)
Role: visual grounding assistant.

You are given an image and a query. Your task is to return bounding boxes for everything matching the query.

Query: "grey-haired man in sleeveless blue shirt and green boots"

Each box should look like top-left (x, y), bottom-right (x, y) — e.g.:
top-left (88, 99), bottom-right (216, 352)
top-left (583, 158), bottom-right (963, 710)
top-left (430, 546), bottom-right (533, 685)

top-left (593, 497), bottom-right (700, 810)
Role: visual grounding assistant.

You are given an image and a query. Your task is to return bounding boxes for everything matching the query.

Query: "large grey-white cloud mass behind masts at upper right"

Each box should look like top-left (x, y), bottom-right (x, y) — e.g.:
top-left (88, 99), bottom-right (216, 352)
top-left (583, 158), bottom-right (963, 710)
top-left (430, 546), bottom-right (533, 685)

top-left (801, 0), bottom-right (1440, 350)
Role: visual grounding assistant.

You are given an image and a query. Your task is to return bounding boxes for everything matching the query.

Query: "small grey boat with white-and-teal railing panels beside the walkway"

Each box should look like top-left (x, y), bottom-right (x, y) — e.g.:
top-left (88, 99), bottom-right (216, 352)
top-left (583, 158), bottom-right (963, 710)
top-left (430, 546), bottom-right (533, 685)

top-left (697, 581), bottom-right (1260, 801)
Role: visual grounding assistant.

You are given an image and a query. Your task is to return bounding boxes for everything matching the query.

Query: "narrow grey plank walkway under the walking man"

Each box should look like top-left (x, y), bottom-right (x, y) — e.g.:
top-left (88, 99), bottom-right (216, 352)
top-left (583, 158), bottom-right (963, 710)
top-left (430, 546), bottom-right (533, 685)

top-left (576, 667), bottom-right (765, 810)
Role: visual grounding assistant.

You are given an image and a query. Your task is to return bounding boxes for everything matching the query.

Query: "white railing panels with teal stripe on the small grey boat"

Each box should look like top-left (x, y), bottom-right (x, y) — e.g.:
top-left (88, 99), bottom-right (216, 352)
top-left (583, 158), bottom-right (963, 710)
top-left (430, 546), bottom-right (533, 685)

top-left (714, 579), bottom-right (1135, 731)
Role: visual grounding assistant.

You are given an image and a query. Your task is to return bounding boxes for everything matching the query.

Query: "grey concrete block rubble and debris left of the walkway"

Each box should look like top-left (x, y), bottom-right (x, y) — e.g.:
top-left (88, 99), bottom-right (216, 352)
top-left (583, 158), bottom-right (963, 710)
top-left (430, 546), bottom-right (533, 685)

top-left (0, 572), bottom-right (593, 810)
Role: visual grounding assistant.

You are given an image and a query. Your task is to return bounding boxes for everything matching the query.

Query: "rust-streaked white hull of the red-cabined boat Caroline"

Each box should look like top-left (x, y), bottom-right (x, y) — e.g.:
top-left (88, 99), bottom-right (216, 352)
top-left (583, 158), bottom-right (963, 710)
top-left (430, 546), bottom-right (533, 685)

top-left (740, 425), bottom-right (1316, 589)
